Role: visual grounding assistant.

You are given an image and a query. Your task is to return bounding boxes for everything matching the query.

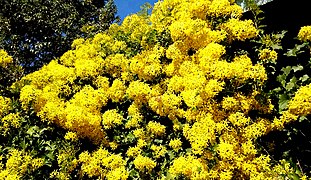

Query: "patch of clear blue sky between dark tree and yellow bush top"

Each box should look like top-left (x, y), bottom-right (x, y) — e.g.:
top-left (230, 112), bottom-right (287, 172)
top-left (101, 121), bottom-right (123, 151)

top-left (114, 0), bottom-right (158, 20)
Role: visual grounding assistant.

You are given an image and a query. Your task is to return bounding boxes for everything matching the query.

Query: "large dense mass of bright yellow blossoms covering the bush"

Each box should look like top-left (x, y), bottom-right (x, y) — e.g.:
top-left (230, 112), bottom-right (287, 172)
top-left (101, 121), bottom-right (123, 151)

top-left (7, 0), bottom-right (311, 179)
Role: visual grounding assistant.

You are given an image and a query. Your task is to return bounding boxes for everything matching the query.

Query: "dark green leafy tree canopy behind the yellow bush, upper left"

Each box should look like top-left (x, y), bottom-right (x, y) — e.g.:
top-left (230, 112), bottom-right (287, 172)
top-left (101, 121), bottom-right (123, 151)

top-left (0, 0), bottom-right (117, 73)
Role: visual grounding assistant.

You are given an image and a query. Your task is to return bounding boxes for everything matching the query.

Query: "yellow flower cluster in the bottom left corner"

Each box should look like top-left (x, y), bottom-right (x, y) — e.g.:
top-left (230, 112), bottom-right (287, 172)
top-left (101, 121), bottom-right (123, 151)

top-left (0, 149), bottom-right (44, 180)
